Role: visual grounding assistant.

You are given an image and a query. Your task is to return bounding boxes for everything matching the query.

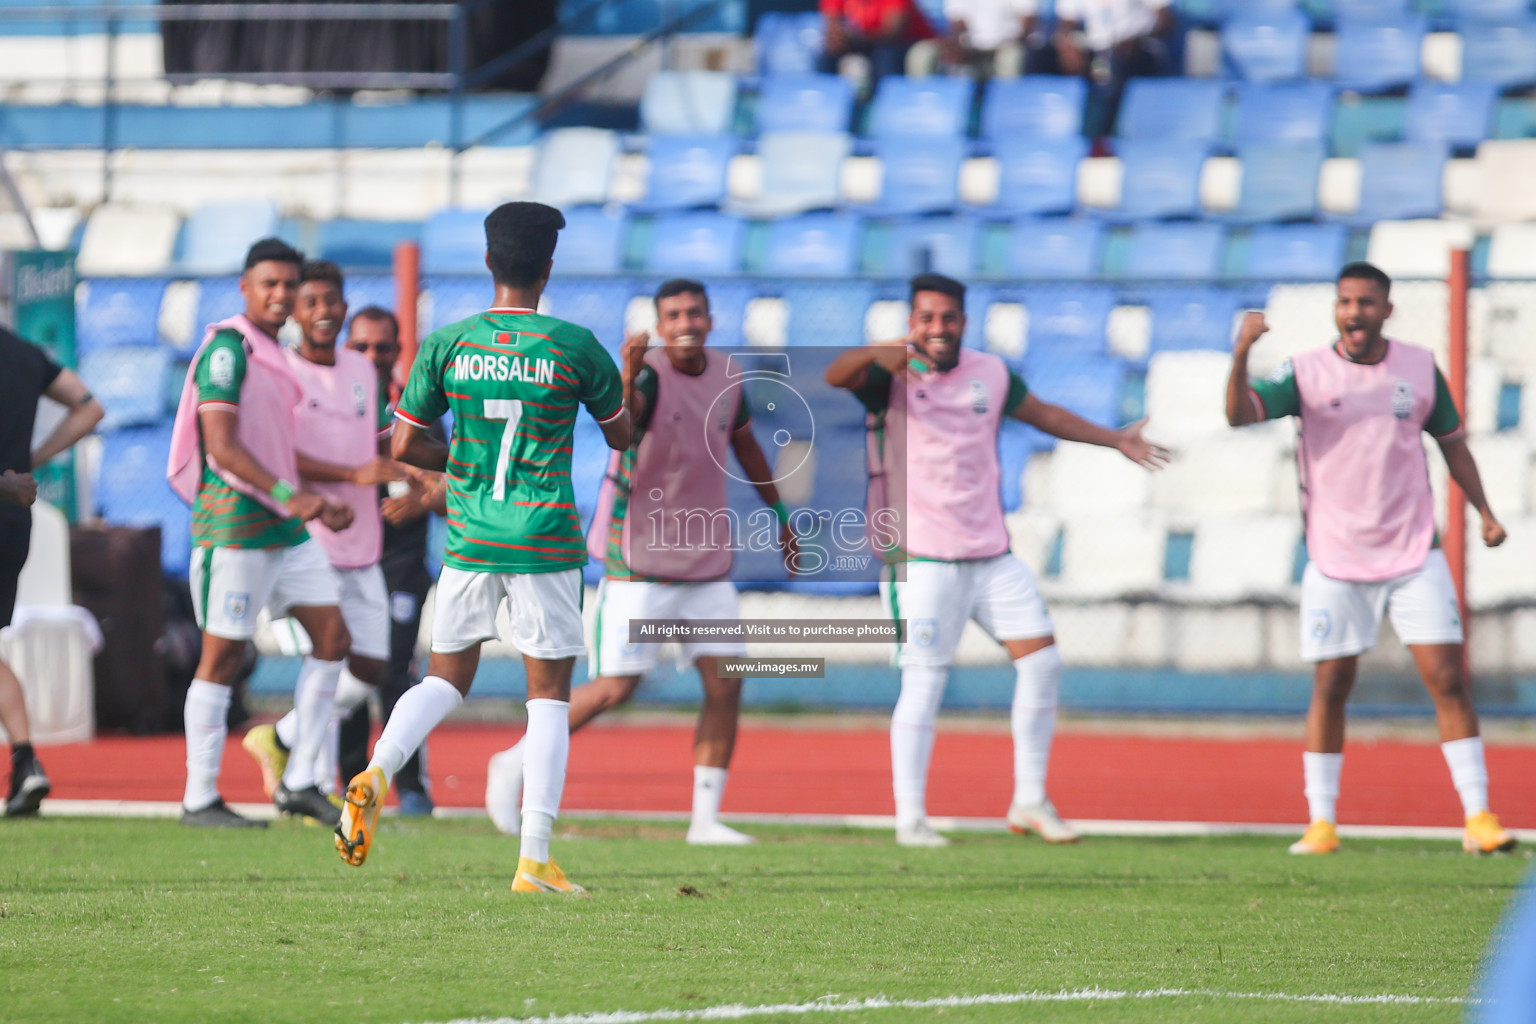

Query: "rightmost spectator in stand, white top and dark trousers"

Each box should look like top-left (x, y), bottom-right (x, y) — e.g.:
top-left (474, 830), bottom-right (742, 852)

top-left (1054, 0), bottom-right (1174, 138)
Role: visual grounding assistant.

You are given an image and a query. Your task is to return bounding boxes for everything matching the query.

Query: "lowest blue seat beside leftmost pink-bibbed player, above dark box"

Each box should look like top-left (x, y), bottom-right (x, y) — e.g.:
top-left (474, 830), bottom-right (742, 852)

top-left (94, 424), bottom-right (192, 577)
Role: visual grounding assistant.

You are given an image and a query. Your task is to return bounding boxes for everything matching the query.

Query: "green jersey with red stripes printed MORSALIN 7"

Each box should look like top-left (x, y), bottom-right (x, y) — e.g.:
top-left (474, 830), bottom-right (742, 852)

top-left (395, 309), bottom-right (624, 573)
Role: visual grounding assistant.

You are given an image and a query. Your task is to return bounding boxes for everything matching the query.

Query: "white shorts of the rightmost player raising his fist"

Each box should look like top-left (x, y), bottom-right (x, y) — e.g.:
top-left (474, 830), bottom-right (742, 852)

top-left (1301, 548), bottom-right (1462, 662)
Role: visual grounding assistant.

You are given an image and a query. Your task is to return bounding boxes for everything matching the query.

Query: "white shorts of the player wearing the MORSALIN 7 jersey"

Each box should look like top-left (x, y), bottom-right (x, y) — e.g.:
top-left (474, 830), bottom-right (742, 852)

top-left (432, 565), bottom-right (587, 662)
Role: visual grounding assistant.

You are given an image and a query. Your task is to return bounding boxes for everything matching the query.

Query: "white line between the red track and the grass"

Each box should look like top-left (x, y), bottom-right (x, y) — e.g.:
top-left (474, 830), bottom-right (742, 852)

top-left (43, 800), bottom-right (1536, 843)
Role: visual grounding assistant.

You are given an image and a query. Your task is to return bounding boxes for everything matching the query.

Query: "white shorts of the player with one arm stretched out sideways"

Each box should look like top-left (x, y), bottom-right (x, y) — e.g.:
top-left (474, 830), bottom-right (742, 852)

top-left (880, 553), bottom-right (1055, 668)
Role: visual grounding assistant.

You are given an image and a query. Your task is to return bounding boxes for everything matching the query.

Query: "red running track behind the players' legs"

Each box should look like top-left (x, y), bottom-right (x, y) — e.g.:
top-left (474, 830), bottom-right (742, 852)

top-left (29, 723), bottom-right (1536, 827)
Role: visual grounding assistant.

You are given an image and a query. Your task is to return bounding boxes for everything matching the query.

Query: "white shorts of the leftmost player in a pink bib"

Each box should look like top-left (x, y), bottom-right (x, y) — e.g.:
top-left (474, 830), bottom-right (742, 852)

top-left (189, 540), bottom-right (341, 640)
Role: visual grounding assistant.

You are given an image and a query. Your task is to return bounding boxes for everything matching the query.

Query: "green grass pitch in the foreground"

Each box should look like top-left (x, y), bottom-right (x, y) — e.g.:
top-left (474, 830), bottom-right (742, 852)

top-left (0, 818), bottom-right (1530, 1024)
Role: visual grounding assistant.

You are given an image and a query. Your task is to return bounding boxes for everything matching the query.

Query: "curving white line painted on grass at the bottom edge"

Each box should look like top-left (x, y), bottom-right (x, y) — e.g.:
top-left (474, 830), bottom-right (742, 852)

top-left (430, 989), bottom-right (1476, 1024)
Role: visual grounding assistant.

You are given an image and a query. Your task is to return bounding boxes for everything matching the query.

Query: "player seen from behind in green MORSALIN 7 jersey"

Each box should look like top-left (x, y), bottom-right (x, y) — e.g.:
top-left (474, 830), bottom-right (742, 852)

top-left (336, 203), bottom-right (633, 892)
